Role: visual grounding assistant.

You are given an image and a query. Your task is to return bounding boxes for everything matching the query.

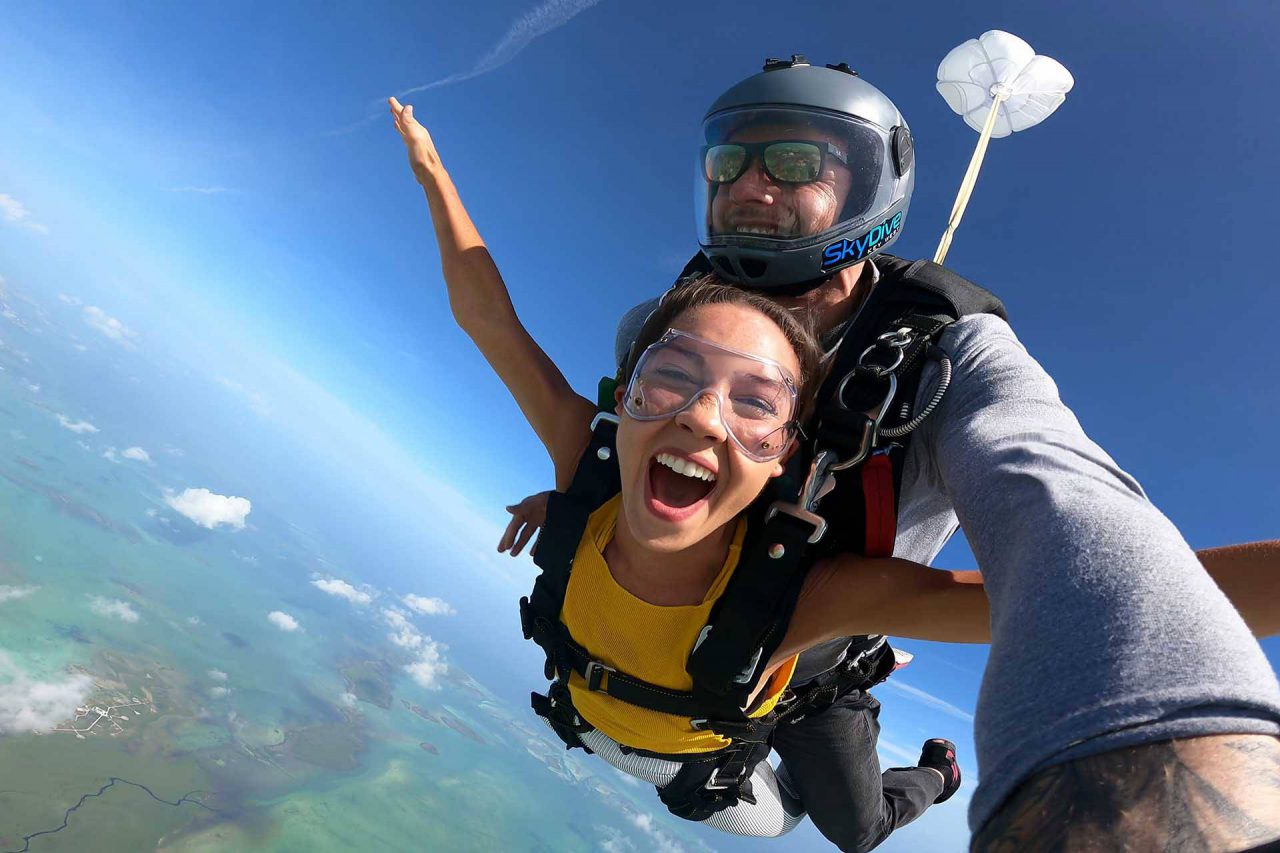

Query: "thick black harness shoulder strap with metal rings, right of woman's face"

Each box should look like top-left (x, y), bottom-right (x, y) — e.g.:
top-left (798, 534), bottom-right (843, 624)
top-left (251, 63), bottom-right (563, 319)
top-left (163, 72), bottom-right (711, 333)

top-left (687, 255), bottom-right (1007, 702)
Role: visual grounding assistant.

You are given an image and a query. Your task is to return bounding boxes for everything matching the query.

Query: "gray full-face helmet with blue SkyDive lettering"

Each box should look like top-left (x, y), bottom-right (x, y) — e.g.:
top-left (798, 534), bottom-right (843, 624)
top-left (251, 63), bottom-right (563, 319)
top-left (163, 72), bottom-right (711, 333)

top-left (695, 56), bottom-right (915, 292)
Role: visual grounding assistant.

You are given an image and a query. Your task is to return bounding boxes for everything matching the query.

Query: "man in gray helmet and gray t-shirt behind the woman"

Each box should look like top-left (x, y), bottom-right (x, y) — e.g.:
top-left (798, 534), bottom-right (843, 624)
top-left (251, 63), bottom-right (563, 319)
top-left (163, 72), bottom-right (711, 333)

top-left (618, 58), bottom-right (1280, 850)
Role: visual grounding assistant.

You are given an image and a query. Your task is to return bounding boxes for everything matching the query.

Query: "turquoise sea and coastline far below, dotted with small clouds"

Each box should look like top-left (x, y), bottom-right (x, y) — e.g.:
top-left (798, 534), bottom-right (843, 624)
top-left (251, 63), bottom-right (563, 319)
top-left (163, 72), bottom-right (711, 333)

top-left (0, 284), bottom-right (705, 850)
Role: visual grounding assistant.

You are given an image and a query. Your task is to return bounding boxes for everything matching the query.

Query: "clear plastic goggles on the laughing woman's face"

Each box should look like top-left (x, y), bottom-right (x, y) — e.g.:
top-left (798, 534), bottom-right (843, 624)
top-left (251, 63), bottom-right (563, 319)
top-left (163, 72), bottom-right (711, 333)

top-left (622, 329), bottom-right (799, 462)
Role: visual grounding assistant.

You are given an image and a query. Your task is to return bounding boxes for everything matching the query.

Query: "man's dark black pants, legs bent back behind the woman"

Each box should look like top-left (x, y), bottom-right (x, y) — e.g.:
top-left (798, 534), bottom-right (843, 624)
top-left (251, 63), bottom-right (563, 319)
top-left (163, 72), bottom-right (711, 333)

top-left (773, 690), bottom-right (942, 850)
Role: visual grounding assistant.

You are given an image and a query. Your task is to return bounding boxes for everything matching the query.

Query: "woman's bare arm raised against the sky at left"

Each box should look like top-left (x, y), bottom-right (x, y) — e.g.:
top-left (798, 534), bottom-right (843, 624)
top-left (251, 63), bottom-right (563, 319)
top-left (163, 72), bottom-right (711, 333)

top-left (389, 97), bottom-right (595, 488)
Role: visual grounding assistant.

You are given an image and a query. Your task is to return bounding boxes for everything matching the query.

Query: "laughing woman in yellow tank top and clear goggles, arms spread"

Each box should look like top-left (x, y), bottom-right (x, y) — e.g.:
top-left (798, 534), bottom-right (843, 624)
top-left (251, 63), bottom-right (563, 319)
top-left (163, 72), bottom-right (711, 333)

top-left (390, 99), bottom-right (987, 835)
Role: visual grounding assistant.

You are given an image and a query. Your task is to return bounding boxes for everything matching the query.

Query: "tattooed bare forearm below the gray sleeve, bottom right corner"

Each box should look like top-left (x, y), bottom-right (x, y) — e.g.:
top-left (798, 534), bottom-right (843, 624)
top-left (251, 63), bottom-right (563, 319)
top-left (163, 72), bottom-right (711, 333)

top-left (972, 735), bottom-right (1280, 853)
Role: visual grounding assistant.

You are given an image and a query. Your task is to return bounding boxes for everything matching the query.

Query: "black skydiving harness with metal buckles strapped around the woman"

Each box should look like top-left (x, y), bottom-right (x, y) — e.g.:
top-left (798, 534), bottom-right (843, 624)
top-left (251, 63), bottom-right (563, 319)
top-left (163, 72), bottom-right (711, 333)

top-left (520, 255), bottom-right (1004, 820)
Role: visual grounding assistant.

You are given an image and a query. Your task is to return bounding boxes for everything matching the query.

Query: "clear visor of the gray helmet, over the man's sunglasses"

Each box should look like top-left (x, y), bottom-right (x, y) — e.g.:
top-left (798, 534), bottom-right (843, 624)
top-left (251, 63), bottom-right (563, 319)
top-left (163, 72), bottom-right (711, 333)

top-left (695, 108), bottom-right (895, 246)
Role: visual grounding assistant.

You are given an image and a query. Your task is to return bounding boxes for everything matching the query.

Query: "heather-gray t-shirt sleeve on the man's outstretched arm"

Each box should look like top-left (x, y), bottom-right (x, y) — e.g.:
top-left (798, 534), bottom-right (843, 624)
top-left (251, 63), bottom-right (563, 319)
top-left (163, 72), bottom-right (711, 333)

top-left (919, 315), bottom-right (1280, 831)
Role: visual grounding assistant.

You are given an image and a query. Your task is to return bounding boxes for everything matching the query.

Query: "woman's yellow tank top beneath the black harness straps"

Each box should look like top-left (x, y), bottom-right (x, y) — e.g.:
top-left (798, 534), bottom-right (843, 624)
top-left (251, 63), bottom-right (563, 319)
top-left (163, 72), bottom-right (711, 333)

top-left (561, 496), bottom-right (796, 754)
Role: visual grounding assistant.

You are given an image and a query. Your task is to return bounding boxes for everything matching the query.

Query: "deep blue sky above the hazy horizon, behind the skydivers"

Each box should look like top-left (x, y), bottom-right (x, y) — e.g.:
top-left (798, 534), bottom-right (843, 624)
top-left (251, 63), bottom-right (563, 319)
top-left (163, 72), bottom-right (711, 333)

top-left (0, 0), bottom-right (1280, 840)
